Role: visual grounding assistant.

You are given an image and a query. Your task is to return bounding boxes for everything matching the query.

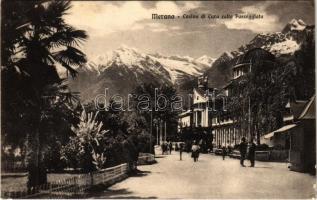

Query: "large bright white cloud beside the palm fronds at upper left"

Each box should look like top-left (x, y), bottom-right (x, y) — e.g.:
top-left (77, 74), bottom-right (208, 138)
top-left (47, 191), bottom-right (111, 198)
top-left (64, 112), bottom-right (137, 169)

top-left (65, 1), bottom-right (200, 36)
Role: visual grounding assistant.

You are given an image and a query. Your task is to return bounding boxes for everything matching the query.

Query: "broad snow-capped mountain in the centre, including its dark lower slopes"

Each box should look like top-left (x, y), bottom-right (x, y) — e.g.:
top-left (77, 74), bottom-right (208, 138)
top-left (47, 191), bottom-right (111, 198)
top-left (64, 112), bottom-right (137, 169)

top-left (70, 46), bottom-right (213, 99)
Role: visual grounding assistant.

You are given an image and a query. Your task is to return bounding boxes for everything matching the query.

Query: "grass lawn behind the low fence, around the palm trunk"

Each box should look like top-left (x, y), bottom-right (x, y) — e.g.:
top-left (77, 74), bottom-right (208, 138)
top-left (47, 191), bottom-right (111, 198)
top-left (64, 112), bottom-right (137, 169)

top-left (1, 173), bottom-right (80, 191)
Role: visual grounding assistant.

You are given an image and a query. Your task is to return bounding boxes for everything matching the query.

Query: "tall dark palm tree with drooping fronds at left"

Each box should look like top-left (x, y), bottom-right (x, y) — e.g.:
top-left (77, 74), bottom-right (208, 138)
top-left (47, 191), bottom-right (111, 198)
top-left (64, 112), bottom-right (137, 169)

top-left (1, 1), bottom-right (87, 188)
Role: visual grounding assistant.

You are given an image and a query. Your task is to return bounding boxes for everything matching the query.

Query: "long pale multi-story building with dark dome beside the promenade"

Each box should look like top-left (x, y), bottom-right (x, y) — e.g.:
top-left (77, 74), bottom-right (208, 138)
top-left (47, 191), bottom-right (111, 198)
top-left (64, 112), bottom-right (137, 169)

top-left (179, 48), bottom-right (314, 153)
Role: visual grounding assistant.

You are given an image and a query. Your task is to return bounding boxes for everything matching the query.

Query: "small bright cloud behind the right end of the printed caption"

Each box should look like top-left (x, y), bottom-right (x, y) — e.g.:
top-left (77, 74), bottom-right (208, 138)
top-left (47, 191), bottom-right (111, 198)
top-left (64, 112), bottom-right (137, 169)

top-left (220, 2), bottom-right (281, 33)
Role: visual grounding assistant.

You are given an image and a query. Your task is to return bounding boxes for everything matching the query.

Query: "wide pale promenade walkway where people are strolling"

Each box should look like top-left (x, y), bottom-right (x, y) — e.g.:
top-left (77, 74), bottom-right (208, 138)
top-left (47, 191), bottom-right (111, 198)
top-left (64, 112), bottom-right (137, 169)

top-left (96, 152), bottom-right (316, 199)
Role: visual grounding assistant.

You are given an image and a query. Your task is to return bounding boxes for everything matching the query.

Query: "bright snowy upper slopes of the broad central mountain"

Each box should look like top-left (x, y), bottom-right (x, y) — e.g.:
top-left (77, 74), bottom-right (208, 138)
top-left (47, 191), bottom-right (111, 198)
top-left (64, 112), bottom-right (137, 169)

top-left (86, 46), bottom-right (213, 84)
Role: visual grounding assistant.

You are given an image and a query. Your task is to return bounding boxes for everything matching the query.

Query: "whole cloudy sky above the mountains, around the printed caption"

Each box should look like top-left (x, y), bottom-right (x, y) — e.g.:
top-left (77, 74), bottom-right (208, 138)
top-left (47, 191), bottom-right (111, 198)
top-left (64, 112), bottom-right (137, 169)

top-left (65, 0), bottom-right (315, 58)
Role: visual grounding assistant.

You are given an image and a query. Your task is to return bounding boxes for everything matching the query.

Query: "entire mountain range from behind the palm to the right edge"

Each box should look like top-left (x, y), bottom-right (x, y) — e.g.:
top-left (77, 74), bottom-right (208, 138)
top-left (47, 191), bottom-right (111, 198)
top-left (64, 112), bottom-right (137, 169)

top-left (69, 19), bottom-right (314, 101)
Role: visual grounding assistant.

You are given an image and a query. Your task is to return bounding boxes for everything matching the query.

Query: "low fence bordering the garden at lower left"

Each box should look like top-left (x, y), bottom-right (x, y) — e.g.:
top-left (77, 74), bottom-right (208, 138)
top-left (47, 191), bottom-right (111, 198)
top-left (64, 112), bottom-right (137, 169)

top-left (1, 164), bottom-right (128, 199)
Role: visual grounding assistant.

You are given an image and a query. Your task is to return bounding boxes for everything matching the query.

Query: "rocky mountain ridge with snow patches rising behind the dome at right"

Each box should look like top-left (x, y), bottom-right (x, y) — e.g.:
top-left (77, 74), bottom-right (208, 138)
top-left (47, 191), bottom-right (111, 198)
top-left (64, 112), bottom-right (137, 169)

top-left (205, 19), bottom-right (314, 88)
